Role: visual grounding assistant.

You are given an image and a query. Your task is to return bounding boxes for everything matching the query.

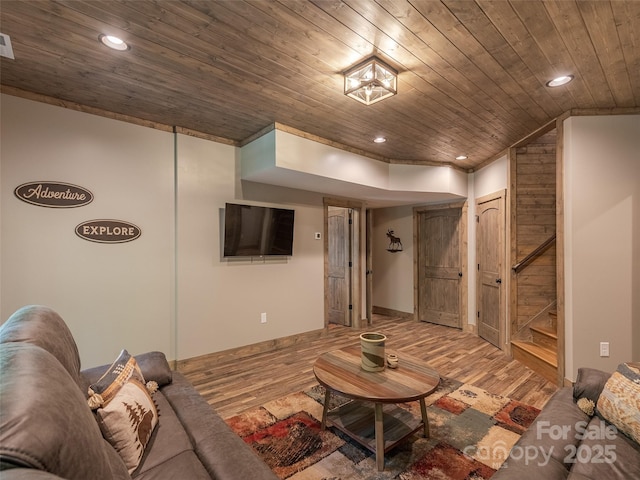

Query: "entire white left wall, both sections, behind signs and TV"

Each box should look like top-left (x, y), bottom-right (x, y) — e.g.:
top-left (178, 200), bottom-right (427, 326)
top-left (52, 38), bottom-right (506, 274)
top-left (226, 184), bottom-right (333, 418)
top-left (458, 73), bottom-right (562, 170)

top-left (0, 95), bottom-right (324, 367)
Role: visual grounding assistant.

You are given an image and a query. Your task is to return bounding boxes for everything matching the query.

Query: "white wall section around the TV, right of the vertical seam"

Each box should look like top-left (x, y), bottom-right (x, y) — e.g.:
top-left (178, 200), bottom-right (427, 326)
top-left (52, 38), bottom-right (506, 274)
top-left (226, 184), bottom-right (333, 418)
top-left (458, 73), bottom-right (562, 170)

top-left (177, 132), bottom-right (324, 358)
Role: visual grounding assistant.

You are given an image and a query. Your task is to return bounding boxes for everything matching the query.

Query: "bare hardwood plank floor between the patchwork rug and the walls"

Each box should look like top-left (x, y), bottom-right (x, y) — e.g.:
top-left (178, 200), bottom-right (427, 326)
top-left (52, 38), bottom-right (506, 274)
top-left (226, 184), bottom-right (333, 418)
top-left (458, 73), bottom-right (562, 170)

top-left (178, 315), bottom-right (557, 418)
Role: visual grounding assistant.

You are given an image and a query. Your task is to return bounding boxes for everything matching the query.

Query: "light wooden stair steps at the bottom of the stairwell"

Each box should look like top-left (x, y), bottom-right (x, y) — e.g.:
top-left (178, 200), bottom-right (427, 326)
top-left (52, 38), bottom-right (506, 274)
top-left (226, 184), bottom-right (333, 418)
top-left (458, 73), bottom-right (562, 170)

top-left (511, 311), bottom-right (558, 383)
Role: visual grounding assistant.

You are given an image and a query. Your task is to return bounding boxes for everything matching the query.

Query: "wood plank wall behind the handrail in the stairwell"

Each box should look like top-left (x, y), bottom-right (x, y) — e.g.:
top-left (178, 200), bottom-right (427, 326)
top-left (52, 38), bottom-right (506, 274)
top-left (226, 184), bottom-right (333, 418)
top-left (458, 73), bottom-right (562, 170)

top-left (511, 129), bottom-right (556, 337)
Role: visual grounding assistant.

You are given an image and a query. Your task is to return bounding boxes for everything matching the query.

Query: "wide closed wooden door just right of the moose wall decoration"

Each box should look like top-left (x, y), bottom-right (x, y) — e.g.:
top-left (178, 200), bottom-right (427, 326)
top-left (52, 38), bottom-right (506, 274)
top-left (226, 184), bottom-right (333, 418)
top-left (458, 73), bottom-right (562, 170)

top-left (418, 208), bottom-right (463, 328)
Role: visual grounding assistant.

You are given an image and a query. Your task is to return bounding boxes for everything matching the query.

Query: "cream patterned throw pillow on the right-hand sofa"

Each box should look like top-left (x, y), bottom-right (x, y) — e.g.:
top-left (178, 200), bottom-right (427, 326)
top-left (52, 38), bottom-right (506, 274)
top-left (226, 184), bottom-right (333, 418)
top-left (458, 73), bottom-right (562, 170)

top-left (598, 363), bottom-right (640, 443)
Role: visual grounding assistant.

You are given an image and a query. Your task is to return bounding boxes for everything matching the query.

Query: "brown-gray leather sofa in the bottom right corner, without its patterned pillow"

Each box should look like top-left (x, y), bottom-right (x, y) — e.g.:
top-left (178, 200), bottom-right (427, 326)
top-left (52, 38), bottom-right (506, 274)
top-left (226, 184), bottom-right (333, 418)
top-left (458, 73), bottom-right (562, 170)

top-left (492, 368), bottom-right (640, 480)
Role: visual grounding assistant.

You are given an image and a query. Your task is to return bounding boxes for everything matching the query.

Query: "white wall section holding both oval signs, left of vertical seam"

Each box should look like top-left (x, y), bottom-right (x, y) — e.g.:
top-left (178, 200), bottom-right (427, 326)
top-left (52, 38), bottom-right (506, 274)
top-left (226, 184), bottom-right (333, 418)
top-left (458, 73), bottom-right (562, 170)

top-left (0, 95), bottom-right (174, 366)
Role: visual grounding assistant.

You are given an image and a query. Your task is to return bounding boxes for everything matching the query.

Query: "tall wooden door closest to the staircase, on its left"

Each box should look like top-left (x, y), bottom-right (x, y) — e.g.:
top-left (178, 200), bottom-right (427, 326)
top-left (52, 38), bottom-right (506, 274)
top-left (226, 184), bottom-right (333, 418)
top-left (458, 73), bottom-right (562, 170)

top-left (476, 194), bottom-right (506, 348)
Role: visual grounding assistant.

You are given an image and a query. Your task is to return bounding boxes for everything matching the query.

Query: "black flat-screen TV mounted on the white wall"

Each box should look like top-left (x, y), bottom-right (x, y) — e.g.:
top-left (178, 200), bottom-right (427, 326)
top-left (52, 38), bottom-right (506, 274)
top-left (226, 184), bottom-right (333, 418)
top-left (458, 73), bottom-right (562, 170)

top-left (224, 203), bottom-right (295, 257)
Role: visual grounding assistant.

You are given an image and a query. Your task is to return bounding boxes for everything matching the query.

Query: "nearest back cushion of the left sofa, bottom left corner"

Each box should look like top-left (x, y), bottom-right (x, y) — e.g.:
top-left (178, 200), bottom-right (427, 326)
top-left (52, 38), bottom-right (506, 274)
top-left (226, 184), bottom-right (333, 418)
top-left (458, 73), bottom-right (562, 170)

top-left (0, 343), bottom-right (127, 480)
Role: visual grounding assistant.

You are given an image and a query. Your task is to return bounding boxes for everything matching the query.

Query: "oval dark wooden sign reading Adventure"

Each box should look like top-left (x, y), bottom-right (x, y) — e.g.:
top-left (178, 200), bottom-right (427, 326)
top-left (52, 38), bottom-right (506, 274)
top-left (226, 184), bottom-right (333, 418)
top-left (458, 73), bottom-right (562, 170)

top-left (14, 182), bottom-right (93, 208)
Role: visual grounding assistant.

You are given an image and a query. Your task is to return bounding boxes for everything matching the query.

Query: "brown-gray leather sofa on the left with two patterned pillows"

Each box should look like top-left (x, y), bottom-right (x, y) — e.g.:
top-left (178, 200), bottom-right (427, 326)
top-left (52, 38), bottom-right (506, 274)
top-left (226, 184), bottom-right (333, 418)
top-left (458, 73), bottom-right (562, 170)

top-left (0, 306), bottom-right (277, 480)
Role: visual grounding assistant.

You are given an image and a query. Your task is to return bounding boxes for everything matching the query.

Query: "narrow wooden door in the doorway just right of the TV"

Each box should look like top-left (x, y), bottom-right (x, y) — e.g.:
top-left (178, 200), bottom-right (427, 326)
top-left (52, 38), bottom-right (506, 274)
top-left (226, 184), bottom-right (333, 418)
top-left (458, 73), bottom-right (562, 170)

top-left (327, 207), bottom-right (351, 326)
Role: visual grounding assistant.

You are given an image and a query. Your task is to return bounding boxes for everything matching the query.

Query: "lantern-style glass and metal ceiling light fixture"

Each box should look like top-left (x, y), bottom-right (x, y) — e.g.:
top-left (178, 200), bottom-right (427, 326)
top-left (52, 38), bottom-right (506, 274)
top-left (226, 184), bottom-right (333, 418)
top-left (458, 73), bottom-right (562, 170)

top-left (344, 56), bottom-right (398, 105)
